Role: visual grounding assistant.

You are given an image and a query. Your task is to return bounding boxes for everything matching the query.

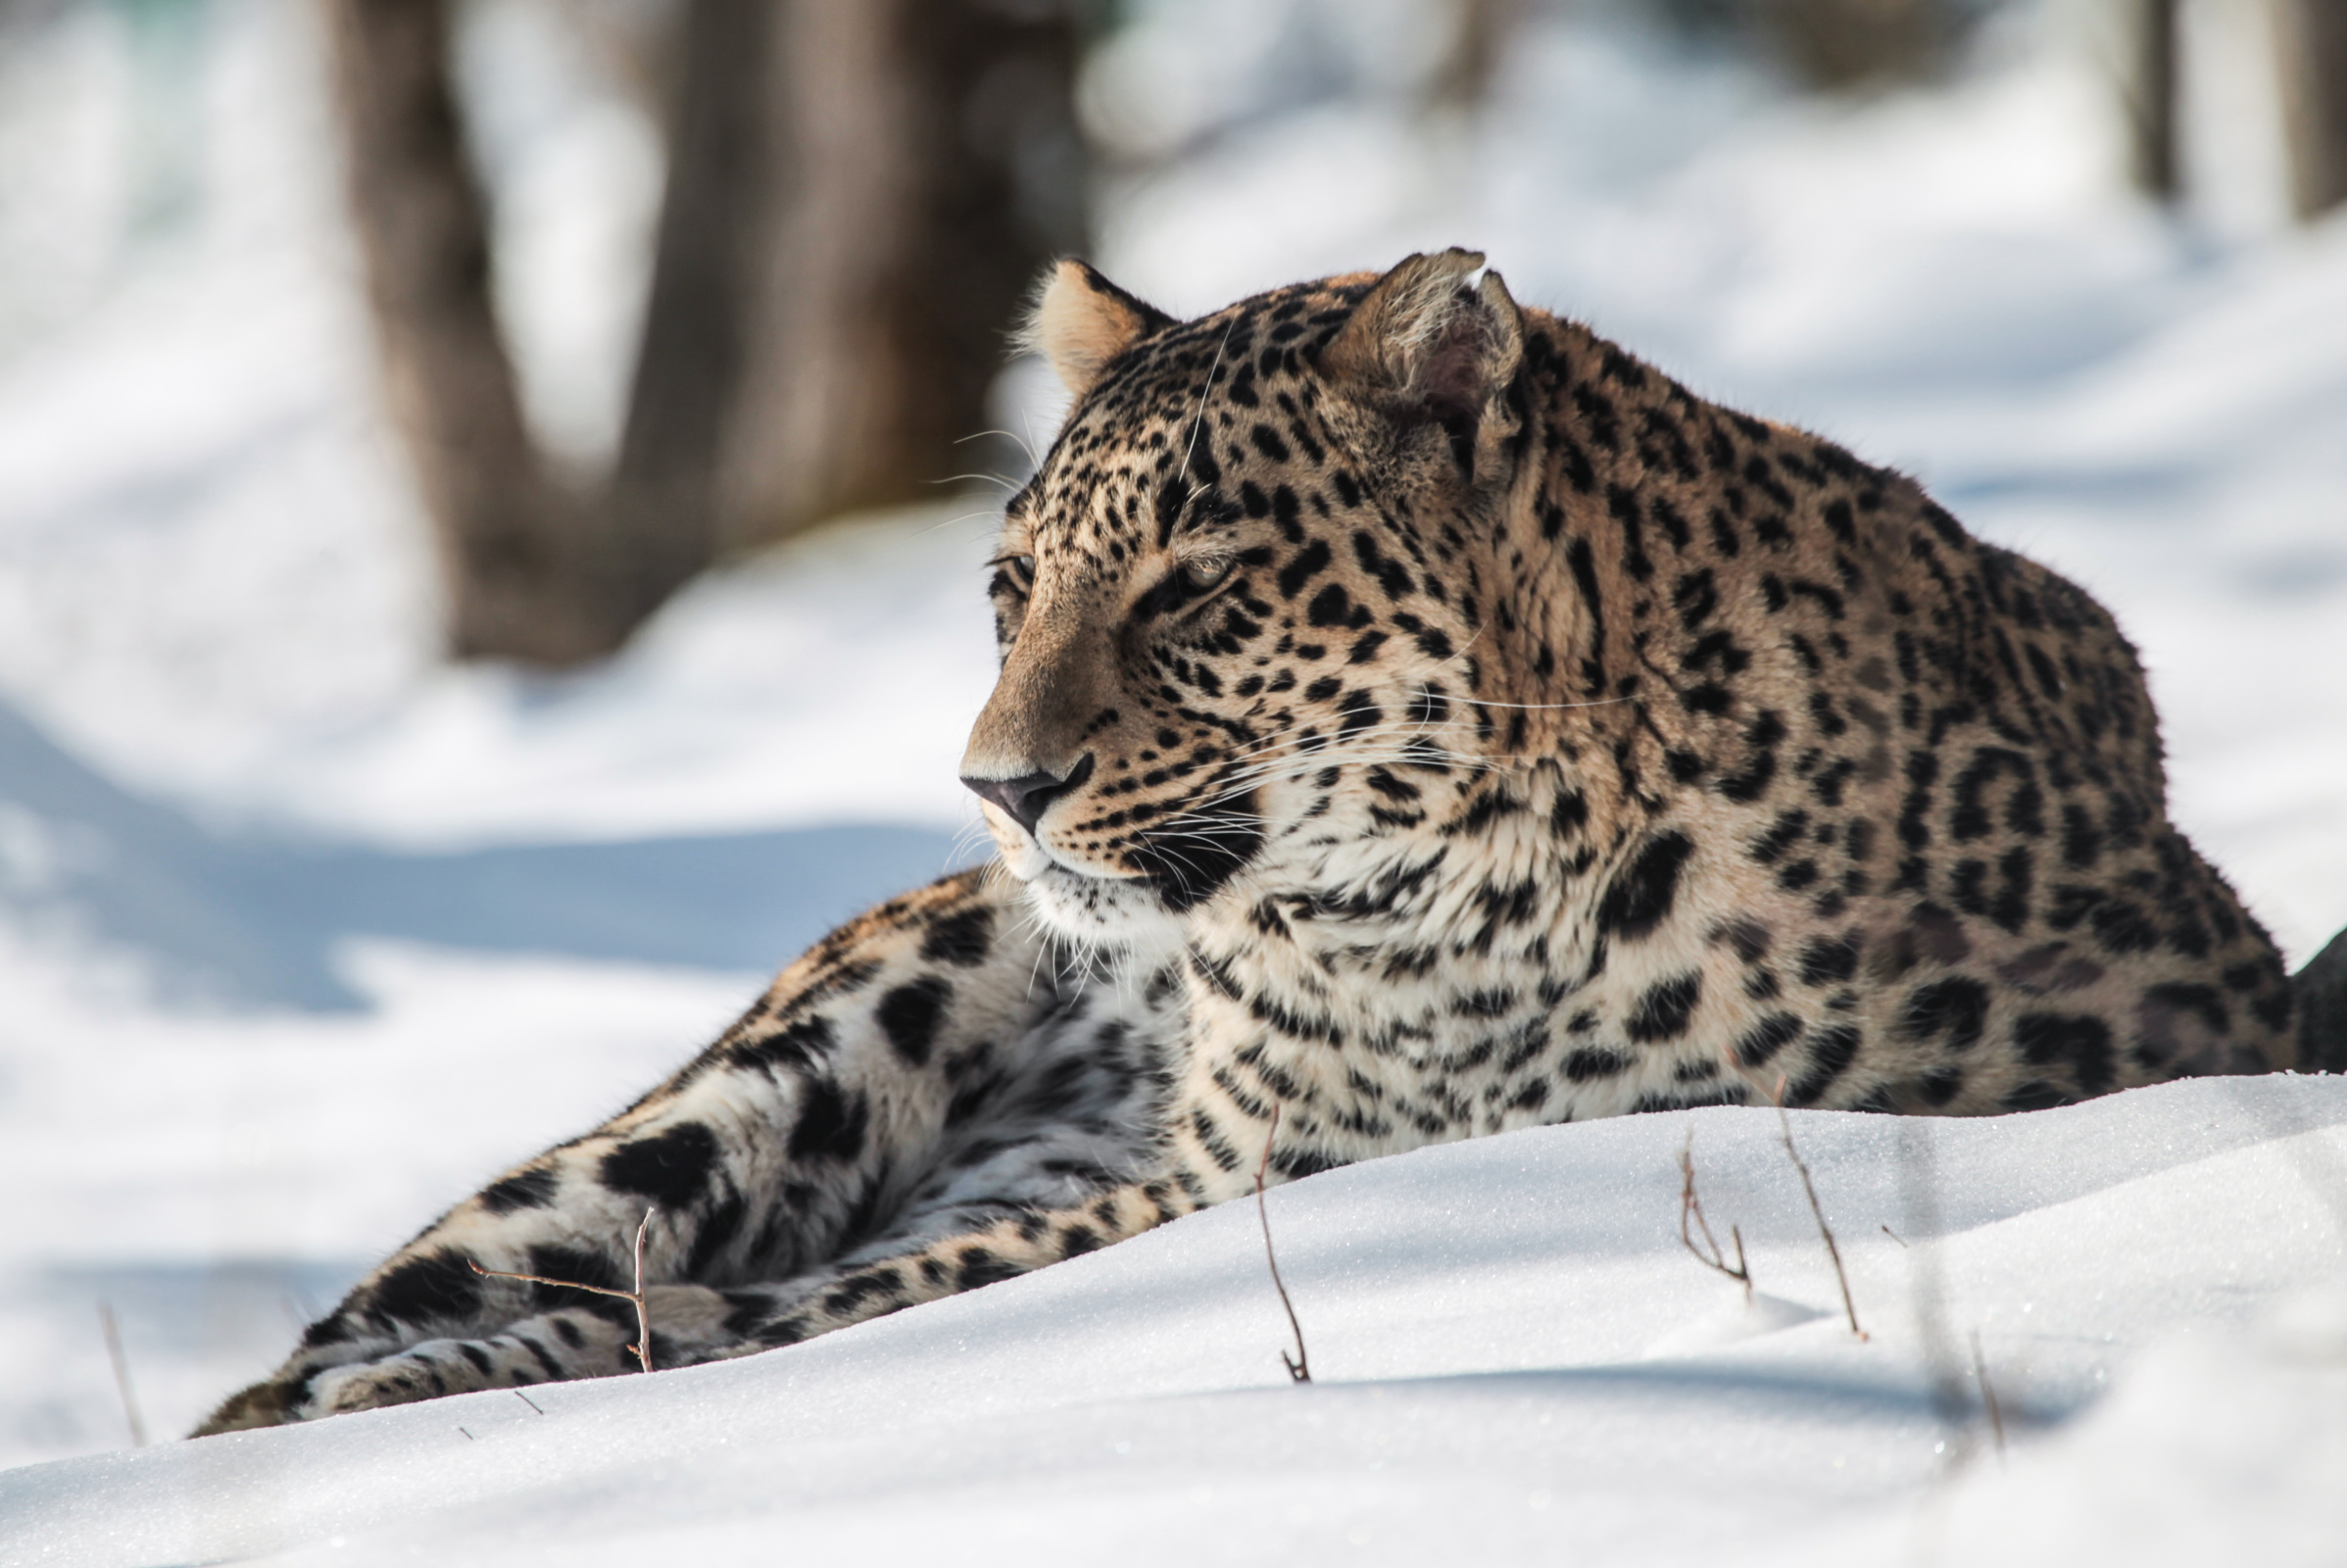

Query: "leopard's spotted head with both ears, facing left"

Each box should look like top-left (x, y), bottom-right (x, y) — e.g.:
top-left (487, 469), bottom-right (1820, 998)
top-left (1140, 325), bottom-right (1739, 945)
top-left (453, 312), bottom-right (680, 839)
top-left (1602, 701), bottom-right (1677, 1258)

top-left (962, 251), bottom-right (1523, 941)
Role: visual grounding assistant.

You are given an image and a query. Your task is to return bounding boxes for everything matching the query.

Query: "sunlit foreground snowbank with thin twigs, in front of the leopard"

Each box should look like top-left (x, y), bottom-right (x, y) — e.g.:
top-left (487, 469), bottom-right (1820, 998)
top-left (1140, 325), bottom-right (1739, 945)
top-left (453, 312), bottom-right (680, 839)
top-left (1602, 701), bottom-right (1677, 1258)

top-left (14, 1080), bottom-right (2347, 1568)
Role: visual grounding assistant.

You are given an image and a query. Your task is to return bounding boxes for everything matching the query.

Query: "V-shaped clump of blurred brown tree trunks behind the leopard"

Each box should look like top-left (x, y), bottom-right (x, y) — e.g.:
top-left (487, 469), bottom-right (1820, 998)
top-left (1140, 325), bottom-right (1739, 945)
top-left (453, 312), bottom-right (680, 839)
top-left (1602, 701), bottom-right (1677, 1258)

top-left (328, 0), bottom-right (1084, 666)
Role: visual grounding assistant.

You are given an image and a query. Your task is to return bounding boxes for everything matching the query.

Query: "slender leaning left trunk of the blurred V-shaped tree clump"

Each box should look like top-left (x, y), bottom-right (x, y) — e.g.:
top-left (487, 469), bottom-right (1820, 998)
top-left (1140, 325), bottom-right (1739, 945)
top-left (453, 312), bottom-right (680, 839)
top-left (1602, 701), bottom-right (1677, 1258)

top-left (328, 0), bottom-right (611, 664)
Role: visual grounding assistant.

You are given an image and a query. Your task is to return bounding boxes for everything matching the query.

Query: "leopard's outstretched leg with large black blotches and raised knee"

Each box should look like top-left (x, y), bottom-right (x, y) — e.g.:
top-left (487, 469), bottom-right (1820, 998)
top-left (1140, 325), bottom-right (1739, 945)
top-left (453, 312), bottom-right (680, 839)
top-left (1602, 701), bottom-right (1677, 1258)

top-left (200, 871), bottom-right (1168, 1434)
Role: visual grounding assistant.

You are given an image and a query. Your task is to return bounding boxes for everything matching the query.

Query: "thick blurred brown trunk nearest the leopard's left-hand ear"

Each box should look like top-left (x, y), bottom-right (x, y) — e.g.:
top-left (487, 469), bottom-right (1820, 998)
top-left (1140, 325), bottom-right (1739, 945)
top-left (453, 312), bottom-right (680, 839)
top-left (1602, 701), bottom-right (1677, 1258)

top-left (720, 0), bottom-right (1084, 547)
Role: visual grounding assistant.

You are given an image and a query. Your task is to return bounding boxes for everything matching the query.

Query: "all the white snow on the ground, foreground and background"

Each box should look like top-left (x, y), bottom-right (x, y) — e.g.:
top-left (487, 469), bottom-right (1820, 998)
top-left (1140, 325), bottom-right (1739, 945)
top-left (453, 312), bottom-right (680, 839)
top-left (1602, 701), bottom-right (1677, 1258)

top-left (0, 0), bottom-right (2347, 1563)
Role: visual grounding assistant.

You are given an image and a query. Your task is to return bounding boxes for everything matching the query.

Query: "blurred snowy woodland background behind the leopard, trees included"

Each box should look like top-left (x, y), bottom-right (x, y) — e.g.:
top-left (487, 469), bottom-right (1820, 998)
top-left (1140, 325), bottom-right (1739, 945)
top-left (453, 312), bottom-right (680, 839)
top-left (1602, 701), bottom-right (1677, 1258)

top-left (0, 0), bottom-right (2347, 1465)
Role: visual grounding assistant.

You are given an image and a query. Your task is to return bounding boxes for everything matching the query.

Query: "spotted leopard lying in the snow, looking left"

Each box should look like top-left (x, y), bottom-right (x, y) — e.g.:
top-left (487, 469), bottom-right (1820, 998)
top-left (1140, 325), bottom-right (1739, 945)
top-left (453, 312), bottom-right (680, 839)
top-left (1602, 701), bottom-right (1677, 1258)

top-left (197, 249), bottom-right (2295, 1434)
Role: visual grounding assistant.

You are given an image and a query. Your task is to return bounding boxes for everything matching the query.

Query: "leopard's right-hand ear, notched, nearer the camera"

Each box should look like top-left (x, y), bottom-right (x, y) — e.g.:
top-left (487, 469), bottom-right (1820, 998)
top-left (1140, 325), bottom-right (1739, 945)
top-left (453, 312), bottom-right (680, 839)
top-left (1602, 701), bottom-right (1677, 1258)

top-left (1321, 249), bottom-right (1523, 479)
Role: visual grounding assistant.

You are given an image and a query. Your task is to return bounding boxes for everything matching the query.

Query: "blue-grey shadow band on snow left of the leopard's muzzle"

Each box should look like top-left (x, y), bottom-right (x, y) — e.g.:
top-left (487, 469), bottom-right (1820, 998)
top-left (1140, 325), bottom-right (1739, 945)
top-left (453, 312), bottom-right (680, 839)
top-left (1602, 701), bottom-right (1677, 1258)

top-left (0, 707), bottom-right (976, 1011)
